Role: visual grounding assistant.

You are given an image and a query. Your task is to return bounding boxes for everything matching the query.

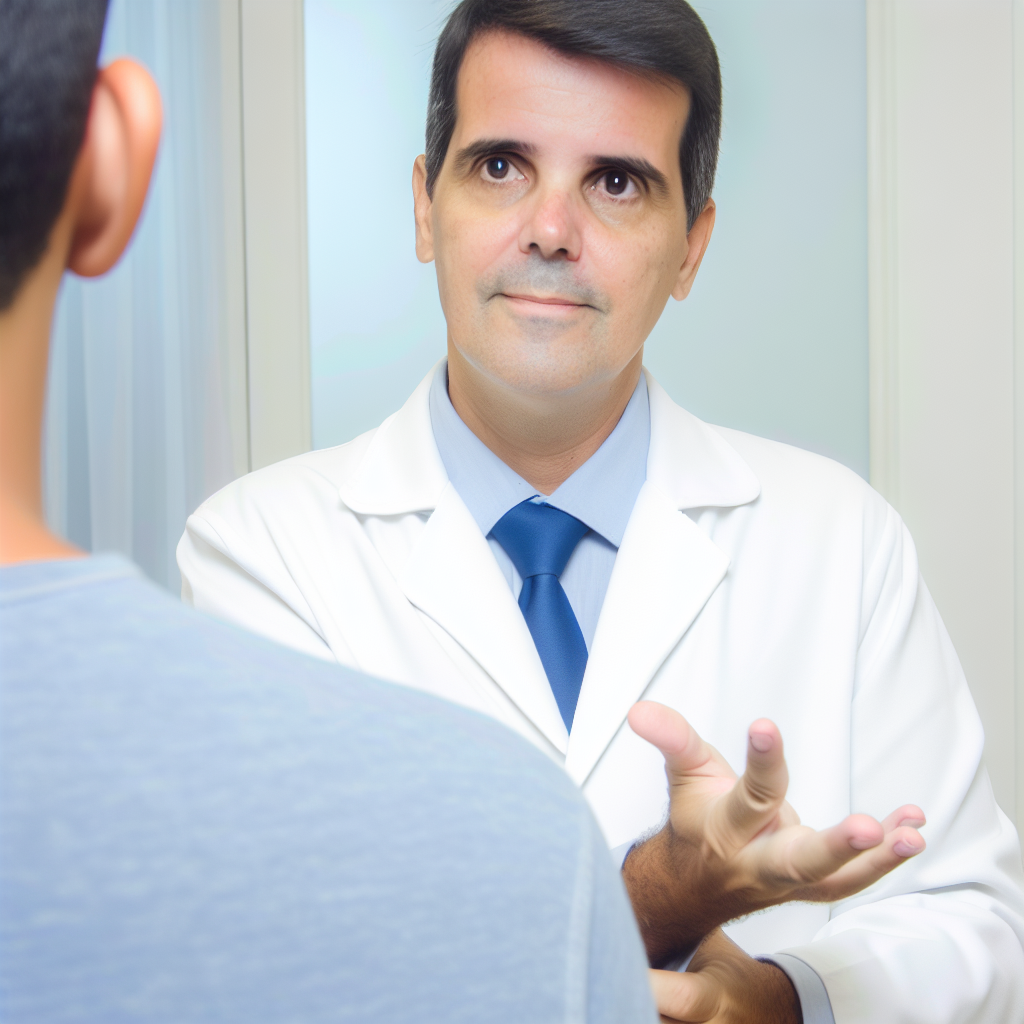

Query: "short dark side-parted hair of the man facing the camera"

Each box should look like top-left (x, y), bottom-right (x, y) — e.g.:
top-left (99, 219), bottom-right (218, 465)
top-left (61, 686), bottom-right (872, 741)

top-left (426, 0), bottom-right (722, 230)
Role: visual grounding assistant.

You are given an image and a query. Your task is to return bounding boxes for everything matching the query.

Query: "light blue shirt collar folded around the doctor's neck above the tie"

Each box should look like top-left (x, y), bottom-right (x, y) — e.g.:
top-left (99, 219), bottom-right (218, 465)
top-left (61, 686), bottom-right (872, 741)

top-left (429, 360), bottom-right (650, 548)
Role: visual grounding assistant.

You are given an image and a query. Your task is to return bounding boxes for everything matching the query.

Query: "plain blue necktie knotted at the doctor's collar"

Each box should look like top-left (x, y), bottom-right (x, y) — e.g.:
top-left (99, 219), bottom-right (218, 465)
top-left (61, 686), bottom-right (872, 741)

top-left (490, 501), bottom-right (590, 730)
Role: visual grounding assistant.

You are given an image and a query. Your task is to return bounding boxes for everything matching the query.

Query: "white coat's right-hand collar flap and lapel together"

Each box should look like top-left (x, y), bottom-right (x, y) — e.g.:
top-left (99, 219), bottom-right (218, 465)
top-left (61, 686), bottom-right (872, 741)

top-left (565, 374), bottom-right (761, 785)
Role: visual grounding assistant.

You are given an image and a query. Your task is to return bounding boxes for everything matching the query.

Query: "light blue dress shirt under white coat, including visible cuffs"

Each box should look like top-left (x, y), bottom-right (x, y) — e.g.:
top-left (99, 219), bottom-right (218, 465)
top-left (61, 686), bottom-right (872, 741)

top-left (430, 360), bottom-right (836, 1024)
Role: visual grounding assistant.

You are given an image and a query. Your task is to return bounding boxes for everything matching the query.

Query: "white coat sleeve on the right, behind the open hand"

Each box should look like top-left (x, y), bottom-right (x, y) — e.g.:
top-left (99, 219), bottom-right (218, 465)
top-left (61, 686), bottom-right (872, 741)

top-left (785, 509), bottom-right (1024, 1024)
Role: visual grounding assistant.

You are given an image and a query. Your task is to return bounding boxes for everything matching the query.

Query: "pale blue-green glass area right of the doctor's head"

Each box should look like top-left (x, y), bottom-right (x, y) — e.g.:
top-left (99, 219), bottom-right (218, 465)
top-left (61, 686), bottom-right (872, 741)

top-left (645, 0), bottom-right (868, 479)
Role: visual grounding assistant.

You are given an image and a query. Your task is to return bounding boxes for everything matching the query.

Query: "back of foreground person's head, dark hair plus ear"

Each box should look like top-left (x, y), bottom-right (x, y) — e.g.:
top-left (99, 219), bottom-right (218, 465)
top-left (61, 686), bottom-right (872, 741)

top-left (0, 0), bottom-right (160, 311)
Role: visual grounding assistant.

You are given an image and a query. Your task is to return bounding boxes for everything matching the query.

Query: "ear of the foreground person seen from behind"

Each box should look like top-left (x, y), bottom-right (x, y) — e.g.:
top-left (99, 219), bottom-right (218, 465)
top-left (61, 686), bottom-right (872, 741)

top-left (68, 58), bottom-right (162, 278)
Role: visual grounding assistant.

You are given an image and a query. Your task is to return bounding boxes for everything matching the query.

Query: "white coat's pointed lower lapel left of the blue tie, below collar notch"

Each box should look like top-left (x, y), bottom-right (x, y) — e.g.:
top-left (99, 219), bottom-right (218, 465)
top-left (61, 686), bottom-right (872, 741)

top-left (398, 483), bottom-right (568, 753)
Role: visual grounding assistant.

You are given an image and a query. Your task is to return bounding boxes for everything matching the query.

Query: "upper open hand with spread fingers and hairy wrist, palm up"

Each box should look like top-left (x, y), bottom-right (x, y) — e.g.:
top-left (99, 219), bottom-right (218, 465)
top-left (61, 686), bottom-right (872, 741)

top-left (623, 700), bottom-right (925, 967)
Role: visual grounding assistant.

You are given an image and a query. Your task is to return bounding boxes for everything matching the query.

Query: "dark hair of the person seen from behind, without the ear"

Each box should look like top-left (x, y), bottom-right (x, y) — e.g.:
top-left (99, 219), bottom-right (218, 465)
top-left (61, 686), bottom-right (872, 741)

top-left (0, 0), bottom-right (108, 310)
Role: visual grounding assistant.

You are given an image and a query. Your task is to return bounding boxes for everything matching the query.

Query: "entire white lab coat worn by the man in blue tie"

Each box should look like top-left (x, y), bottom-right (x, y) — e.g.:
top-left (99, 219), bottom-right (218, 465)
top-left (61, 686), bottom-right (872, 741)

top-left (178, 364), bottom-right (1024, 1024)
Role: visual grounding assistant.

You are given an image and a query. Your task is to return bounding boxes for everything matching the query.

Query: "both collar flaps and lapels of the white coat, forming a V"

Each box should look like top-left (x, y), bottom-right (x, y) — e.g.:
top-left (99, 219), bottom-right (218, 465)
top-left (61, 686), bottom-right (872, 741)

top-left (339, 362), bottom-right (760, 770)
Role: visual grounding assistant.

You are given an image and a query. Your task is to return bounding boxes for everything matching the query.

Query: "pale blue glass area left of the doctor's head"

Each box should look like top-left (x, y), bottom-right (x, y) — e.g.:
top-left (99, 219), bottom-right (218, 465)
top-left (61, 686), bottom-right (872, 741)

top-left (305, 0), bottom-right (451, 447)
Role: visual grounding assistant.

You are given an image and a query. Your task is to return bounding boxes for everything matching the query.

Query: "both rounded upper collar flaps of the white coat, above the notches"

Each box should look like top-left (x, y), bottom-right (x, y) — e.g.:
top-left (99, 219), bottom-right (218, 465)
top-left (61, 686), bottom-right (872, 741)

top-left (338, 366), bottom-right (761, 515)
